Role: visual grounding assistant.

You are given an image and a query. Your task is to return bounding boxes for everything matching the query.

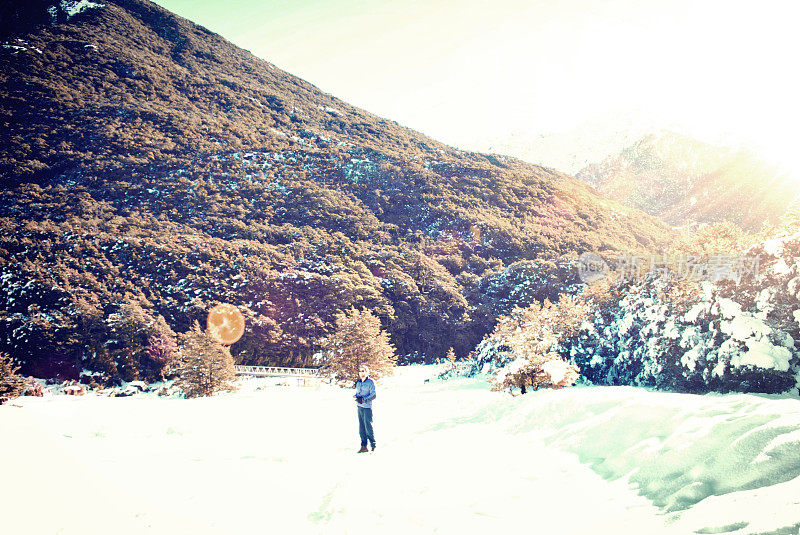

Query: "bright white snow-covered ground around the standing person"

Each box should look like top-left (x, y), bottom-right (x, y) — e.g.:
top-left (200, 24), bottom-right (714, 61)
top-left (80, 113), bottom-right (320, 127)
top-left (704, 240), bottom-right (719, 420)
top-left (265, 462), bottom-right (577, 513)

top-left (0, 366), bottom-right (800, 535)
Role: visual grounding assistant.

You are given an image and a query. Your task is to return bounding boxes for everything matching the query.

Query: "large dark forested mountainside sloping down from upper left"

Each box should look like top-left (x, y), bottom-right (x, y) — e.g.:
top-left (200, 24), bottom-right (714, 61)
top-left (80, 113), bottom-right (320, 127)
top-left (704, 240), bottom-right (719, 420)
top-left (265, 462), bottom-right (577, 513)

top-left (0, 0), bottom-right (676, 386)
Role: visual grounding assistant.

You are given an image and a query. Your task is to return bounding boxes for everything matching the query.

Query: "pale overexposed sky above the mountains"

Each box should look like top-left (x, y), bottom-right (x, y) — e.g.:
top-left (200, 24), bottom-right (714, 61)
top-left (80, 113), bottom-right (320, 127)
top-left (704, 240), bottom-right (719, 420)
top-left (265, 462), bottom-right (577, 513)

top-left (152, 0), bottom-right (800, 175)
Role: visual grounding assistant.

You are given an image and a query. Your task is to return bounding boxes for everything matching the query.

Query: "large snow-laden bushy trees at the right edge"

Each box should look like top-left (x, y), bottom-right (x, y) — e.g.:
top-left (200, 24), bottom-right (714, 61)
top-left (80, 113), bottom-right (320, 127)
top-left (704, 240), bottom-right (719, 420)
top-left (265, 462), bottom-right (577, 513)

top-left (561, 234), bottom-right (800, 395)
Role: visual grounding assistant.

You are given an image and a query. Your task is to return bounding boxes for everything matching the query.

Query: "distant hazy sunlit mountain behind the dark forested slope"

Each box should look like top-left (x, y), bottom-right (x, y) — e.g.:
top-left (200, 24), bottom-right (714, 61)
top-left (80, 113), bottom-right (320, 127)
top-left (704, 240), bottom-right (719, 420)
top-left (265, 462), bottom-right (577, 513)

top-left (576, 132), bottom-right (800, 232)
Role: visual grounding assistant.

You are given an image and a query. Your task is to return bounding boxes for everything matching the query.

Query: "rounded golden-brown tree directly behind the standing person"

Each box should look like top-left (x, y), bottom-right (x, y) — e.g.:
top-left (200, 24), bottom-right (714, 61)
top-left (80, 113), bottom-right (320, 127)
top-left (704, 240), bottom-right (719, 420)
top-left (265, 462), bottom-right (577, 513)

top-left (323, 309), bottom-right (397, 381)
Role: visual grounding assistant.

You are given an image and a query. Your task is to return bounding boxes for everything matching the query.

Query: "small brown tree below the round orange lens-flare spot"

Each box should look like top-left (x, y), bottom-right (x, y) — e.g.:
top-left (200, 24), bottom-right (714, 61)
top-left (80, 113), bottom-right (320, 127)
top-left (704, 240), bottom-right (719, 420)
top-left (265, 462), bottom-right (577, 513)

top-left (176, 321), bottom-right (236, 398)
